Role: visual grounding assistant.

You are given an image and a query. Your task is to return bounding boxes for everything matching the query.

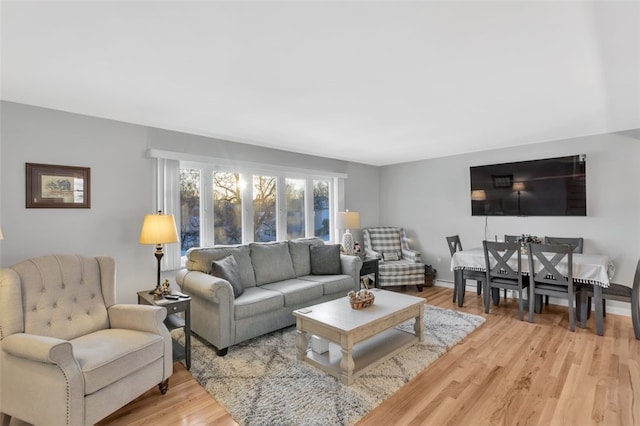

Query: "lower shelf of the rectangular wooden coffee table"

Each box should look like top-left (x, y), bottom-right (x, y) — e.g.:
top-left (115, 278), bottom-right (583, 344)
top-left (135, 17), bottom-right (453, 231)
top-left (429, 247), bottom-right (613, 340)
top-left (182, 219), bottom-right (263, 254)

top-left (306, 328), bottom-right (419, 385)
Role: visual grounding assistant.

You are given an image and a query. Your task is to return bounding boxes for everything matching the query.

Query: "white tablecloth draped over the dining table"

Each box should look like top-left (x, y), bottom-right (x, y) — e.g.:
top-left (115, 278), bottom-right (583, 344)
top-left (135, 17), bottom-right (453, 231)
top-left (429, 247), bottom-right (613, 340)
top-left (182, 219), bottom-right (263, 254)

top-left (451, 248), bottom-right (615, 287)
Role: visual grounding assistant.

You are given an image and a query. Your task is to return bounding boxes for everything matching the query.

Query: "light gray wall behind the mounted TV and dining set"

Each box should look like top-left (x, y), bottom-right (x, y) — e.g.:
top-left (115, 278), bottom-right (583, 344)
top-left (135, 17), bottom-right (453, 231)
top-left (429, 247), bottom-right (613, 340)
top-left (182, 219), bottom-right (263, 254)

top-left (380, 130), bottom-right (640, 292)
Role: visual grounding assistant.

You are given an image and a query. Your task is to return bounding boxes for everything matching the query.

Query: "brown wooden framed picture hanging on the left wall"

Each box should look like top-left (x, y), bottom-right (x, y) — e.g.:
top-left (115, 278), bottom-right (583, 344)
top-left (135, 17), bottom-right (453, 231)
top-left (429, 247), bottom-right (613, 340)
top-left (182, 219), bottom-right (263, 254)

top-left (26, 163), bottom-right (91, 209)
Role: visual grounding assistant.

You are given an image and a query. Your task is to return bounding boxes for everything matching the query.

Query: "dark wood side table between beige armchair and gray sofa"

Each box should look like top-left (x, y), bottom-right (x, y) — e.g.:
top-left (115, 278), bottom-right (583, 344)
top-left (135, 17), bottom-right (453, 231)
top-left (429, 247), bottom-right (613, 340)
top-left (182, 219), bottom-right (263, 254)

top-left (138, 291), bottom-right (191, 370)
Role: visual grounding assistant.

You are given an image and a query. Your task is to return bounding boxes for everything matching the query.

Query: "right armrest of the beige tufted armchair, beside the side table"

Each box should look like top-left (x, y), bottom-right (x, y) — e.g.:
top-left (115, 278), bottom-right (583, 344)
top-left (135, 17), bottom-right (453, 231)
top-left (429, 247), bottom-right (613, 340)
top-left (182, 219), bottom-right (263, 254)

top-left (107, 304), bottom-right (167, 335)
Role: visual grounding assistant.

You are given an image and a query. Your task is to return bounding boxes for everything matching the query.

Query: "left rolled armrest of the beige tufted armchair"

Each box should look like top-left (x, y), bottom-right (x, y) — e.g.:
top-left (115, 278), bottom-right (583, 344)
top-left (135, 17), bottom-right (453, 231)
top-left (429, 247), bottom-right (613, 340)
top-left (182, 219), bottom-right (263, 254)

top-left (2, 333), bottom-right (75, 364)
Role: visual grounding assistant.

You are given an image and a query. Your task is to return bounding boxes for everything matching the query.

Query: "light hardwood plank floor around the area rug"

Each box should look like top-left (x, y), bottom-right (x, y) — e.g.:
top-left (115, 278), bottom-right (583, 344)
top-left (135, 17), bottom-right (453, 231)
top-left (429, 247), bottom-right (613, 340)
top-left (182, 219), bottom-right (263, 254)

top-left (100, 287), bottom-right (640, 426)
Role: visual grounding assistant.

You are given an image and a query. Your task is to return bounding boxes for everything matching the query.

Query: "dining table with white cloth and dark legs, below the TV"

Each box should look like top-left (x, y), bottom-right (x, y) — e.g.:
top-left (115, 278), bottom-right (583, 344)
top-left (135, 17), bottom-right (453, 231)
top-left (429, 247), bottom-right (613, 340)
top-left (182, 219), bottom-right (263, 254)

top-left (451, 248), bottom-right (615, 306)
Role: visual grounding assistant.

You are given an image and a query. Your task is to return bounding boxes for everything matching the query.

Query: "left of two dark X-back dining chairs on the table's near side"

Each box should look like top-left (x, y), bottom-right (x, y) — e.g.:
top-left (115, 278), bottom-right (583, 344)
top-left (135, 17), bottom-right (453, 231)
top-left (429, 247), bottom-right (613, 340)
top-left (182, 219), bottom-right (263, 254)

top-left (482, 241), bottom-right (529, 321)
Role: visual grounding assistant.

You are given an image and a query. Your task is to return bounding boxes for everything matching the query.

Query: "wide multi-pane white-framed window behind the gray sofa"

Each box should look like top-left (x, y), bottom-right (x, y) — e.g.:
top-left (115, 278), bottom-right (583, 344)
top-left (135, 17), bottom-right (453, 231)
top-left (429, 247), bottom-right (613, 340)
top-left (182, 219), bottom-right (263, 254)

top-left (179, 161), bottom-right (337, 248)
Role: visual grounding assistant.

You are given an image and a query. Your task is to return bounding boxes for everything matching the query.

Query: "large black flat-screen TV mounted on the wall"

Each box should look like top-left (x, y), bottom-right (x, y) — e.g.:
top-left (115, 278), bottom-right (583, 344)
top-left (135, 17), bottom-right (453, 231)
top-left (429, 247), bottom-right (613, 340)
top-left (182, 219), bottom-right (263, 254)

top-left (470, 154), bottom-right (587, 216)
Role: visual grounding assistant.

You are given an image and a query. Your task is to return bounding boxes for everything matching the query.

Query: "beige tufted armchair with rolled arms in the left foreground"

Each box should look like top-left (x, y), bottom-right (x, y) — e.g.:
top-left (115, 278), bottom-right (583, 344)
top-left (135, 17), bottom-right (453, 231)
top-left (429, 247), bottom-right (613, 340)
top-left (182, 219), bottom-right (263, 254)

top-left (0, 255), bottom-right (173, 425)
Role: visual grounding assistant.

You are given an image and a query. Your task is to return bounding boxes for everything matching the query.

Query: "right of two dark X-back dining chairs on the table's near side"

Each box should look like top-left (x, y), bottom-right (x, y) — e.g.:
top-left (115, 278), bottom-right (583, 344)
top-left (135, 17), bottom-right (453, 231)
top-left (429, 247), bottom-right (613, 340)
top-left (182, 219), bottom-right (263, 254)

top-left (527, 243), bottom-right (576, 331)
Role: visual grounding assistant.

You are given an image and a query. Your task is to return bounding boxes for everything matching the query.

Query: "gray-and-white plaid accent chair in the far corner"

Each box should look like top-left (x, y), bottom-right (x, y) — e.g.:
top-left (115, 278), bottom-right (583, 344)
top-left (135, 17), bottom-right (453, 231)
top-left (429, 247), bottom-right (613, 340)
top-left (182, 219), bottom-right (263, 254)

top-left (363, 227), bottom-right (424, 290)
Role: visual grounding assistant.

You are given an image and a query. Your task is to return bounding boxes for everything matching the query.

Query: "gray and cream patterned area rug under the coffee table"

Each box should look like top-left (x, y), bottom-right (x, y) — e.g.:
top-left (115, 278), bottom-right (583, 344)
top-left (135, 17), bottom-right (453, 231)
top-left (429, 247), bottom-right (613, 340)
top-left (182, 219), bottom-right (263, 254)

top-left (173, 305), bottom-right (485, 426)
